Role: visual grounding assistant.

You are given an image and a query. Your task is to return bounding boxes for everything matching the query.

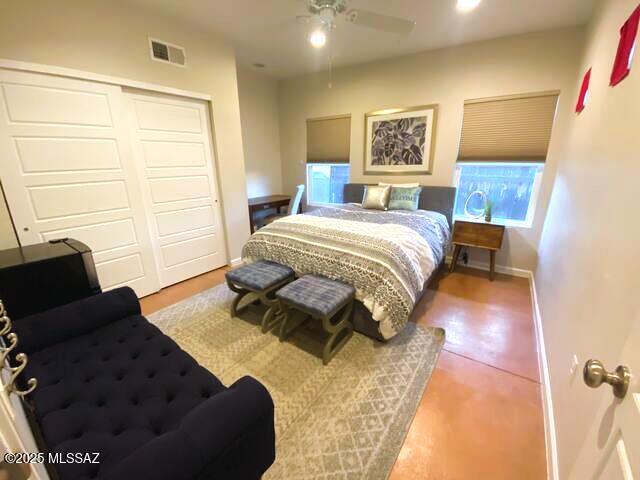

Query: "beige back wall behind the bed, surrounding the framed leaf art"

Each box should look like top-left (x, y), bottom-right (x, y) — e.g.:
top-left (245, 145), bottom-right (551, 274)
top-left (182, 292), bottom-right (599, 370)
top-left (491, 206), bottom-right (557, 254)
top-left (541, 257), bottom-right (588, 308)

top-left (279, 28), bottom-right (583, 270)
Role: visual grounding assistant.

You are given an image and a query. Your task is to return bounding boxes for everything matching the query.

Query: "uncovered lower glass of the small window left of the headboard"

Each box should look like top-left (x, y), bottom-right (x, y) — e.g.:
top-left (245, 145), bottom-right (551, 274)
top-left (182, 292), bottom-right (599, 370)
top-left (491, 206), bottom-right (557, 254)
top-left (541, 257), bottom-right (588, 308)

top-left (307, 163), bottom-right (349, 205)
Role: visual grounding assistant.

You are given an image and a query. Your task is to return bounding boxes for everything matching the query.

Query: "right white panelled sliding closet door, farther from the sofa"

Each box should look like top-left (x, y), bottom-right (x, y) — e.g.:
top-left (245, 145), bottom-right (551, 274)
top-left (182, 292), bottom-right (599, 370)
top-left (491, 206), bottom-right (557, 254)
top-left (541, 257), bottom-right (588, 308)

top-left (126, 93), bottom-right (226, 287)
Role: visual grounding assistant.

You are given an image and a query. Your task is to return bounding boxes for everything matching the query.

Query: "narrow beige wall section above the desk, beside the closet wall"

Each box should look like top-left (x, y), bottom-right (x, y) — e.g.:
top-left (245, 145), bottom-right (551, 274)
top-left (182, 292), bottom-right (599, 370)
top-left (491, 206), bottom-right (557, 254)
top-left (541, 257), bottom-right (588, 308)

top-left (238, 66), bottom-right (283, 197)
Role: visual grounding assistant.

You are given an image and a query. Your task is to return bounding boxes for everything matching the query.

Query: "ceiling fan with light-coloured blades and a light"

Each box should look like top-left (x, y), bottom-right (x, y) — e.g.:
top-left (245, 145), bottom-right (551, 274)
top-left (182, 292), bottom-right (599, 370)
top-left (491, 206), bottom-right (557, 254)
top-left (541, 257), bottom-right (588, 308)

top-left (298, 0), bottom-right (416, 35)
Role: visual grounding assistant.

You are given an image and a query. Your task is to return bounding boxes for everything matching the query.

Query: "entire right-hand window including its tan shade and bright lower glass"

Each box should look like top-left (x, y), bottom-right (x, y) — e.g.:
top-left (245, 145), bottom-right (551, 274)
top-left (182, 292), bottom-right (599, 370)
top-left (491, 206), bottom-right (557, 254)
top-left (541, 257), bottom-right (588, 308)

top-left (454, 92), bottom-right (558, 227)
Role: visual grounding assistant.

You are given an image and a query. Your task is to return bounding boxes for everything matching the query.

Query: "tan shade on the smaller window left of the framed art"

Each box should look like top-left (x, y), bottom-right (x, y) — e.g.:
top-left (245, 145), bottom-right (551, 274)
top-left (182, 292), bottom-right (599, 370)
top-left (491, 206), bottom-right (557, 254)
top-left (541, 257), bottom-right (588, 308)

top-left (307, 117), bottom-right (351, 163)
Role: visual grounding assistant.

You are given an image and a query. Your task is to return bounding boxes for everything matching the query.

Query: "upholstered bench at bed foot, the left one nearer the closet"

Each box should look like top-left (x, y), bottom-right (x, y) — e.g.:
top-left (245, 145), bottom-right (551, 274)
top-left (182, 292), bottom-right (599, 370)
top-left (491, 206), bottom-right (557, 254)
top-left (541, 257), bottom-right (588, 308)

top-left (226, 260), bottom-right (295, 333)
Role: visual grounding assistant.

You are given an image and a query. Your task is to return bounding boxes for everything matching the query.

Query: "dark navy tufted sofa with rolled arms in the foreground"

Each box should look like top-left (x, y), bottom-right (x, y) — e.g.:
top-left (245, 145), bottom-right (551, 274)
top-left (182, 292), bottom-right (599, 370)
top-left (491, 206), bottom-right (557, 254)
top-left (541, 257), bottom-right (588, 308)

top-left (14, 288), bottom-right (275, 480)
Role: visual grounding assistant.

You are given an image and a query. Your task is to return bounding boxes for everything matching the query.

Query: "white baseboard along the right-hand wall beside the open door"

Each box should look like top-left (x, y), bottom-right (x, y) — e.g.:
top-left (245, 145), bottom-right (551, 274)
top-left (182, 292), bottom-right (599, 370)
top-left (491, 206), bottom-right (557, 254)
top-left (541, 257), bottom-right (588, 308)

top-left (529, 272), bottom-right (560, 480)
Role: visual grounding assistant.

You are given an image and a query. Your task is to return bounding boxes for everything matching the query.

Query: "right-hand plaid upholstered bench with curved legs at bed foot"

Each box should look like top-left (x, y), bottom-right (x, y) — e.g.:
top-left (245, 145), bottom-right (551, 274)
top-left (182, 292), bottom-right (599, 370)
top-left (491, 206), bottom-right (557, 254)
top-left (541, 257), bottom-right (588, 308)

top-left (276, 275), bottom-right (356, 365)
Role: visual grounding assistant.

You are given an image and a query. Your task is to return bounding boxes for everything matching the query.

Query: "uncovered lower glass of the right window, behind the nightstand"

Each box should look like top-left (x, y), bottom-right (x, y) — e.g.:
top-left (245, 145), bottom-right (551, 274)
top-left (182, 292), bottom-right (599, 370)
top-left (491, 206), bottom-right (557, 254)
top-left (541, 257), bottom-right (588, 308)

top-left (454, 162), bottom-right (544, 227)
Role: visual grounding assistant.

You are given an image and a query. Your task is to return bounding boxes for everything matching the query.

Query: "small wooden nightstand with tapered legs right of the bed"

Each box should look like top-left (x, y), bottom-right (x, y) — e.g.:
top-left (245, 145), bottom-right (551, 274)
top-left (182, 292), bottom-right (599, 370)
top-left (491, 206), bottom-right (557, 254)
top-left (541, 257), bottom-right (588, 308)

top-left (449, 220), bottom-right (504, 280)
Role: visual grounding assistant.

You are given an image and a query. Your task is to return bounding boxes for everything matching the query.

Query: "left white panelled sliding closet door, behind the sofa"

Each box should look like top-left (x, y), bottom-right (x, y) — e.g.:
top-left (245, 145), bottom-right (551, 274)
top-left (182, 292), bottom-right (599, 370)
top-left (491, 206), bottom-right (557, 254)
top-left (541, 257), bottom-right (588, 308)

top-left (0, 70), bottom-right (159, 296)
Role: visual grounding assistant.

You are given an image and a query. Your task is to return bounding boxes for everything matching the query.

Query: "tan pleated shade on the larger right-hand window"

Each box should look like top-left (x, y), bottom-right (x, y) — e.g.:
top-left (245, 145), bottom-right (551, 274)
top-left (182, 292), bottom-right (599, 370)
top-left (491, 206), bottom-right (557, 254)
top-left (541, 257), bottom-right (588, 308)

top-left (458, 92), bottom-right (558, 162)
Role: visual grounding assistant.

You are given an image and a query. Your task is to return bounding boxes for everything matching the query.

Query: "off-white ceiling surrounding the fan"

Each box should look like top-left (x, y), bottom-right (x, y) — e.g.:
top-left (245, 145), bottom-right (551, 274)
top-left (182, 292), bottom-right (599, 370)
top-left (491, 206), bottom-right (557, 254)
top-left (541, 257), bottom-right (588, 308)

top-left (129, 0), bottom-right (597, 78)
